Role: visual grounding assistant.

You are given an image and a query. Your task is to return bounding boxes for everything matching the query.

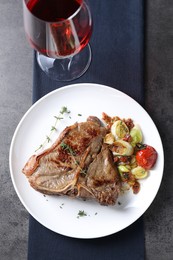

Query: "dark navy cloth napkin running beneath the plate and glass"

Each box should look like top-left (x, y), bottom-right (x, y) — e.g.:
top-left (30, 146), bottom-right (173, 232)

top-left (28, 0), bottom-right (145, 260)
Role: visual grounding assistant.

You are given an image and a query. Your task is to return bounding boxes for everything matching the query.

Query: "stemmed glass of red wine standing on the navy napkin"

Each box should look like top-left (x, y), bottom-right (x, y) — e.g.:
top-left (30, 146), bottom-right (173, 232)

top-left (23, 0), bottom-right (92, 81)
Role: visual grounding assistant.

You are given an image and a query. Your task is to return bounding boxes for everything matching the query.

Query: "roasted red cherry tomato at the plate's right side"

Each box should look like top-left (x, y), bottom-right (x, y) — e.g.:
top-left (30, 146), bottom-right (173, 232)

top-left (136, 145), bottom-right (157, 170)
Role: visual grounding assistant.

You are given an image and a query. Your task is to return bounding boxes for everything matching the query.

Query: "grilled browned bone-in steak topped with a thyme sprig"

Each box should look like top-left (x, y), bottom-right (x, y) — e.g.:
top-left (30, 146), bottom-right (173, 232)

top-left (22, 117), bottom-right (120, 205)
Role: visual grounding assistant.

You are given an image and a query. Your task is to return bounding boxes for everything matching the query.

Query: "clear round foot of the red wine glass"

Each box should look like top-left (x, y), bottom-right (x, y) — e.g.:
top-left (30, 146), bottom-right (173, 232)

top-left (37, 44), bottom-right (91, 81)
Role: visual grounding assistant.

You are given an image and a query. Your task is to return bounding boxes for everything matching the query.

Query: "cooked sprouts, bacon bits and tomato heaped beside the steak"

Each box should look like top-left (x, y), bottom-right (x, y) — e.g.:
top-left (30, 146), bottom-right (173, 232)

top-left (102, 113), bottom-right (157, 194)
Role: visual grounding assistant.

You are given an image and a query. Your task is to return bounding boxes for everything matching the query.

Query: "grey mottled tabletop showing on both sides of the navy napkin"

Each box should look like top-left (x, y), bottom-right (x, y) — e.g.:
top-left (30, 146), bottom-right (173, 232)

top-left (0, 0), bottom-right (173, 260)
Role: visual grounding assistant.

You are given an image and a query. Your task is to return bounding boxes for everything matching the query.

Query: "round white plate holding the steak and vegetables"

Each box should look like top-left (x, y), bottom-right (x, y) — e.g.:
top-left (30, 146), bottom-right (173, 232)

top-left (9, 83), bottom-right (164, 238)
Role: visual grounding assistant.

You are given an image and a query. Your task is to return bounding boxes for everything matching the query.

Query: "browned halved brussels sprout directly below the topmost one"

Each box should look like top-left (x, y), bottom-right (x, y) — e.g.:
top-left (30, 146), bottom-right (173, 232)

top-left (112, 140), bottom-right (134, 156)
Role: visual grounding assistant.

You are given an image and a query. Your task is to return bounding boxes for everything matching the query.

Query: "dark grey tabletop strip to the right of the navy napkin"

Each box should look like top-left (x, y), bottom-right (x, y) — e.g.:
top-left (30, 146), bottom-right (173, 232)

top-left (145, 0), bottom-right (173, 260)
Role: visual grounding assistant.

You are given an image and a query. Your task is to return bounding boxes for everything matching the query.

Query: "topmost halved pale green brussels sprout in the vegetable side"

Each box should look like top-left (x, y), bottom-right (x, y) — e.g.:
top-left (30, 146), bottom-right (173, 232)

top-left (111, 120), bottom-right (129, 140)
